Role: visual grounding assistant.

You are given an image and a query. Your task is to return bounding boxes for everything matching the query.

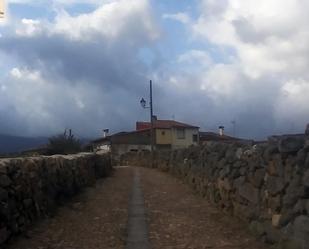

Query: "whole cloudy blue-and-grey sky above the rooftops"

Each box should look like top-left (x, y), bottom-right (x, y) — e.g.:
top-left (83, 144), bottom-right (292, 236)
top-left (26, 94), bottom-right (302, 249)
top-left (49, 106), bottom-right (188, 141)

top-left (0, 0), bottom-right (309, 139)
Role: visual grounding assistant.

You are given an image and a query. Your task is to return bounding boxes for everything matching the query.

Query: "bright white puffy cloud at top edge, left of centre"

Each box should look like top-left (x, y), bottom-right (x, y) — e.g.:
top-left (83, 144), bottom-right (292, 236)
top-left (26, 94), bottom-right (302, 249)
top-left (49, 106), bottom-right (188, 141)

top-left (51, 0), bottom-right (158, 41)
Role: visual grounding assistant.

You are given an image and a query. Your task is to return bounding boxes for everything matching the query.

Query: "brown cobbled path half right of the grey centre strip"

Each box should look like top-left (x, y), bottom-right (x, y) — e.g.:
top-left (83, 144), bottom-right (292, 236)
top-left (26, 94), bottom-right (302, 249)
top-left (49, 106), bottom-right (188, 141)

top-left (141, 169), bottom-right (269, 249)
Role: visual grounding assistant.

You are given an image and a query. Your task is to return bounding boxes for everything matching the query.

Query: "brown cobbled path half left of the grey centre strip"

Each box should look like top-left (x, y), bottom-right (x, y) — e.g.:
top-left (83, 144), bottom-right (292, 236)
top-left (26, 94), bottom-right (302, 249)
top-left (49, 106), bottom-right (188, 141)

top-left (7, 168), bottom-right (132, 249)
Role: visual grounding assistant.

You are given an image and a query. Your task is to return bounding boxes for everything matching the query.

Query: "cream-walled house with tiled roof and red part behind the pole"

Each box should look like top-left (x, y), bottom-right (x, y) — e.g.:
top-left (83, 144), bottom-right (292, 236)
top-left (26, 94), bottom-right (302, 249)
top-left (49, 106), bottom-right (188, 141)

top-left (136, 120), bottom-right (199, 149)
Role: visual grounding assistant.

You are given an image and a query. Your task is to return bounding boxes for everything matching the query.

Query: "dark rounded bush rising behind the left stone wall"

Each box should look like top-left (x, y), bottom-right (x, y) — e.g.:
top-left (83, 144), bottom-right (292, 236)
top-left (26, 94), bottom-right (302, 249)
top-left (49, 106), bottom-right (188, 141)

top-left (47, 129), bottom-right (82, 155)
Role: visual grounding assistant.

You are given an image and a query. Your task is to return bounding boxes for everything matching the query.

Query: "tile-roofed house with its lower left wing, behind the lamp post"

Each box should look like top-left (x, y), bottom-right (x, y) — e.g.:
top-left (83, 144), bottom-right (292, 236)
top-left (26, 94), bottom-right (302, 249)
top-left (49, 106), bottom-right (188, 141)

top-left (91, 120), bottom-right (199, 161)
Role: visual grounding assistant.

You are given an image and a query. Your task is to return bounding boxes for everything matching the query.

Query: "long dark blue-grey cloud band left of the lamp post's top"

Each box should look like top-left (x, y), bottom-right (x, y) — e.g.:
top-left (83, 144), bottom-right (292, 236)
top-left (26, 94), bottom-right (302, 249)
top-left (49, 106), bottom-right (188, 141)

top-left (0, 35), bottom-right (147, 94)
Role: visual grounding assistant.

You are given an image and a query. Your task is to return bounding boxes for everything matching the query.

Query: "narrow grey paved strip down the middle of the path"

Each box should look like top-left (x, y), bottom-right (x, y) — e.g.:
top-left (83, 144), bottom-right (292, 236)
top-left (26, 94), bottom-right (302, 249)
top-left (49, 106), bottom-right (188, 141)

top-left (126, 169), bottom-right (150, 249)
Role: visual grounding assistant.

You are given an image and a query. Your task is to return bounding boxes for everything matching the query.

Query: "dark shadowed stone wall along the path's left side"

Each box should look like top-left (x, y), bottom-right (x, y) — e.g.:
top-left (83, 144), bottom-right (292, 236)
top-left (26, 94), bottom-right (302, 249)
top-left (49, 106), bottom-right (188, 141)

top-left (0, 153), bottom-right (112, 247)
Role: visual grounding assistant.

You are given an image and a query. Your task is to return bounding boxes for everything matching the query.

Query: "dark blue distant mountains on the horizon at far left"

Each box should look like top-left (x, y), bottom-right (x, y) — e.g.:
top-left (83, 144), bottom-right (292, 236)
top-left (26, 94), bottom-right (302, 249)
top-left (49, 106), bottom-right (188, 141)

top-left (0, 134), bottom-right (48, 154)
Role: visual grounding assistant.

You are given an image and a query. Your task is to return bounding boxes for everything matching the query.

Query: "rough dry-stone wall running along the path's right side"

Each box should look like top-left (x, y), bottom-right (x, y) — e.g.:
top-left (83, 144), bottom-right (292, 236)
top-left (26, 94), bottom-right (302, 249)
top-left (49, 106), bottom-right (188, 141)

top-left (122, 137), bottom-right (309, 249)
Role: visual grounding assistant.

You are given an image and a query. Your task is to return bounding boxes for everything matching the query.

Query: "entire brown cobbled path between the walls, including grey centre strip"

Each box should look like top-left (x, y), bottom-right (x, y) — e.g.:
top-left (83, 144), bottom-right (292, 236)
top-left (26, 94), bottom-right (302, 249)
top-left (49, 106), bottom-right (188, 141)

top-left (6, 167), bottom-right (269, 249)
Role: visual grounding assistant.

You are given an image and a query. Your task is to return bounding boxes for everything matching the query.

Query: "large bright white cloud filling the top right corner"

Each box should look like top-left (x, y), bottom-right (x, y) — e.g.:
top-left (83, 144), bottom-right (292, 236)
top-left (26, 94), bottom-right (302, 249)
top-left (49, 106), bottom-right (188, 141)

top-left (192, 0), bottom-right (309, 78)
